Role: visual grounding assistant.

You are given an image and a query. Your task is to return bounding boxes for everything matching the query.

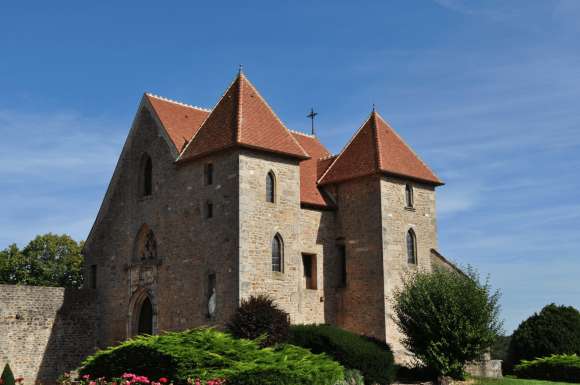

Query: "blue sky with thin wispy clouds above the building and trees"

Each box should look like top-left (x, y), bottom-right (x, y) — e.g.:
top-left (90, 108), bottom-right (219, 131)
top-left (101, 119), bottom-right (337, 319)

top-left (0, 0), bottom-right (580, 332)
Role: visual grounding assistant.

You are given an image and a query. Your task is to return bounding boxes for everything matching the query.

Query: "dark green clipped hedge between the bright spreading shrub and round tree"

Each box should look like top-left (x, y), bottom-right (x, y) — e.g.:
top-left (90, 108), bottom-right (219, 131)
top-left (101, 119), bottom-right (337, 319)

top-left (289, 325), bottom-right (395, 385)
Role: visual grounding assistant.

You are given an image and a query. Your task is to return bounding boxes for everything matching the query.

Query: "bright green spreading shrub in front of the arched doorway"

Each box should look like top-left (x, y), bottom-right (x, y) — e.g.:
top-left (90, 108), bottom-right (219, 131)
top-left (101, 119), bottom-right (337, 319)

top-left (80, 329), bottom-right (344, 385)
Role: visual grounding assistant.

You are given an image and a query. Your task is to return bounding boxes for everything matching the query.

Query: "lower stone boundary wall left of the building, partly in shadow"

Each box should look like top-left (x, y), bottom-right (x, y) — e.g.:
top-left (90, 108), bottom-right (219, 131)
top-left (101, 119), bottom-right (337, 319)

top-left (0, 285), bottom-right (96, 385)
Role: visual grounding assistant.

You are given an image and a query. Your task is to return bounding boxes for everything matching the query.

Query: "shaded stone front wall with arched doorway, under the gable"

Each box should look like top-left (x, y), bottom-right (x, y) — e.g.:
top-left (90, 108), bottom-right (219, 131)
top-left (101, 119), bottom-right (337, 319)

top-left (86, 107), bottom-right (238, 346)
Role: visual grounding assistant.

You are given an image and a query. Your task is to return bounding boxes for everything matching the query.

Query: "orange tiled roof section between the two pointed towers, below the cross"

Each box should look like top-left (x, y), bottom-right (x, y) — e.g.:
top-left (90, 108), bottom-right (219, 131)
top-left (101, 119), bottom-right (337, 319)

top-left (292, 131), bottom-right (330, 207)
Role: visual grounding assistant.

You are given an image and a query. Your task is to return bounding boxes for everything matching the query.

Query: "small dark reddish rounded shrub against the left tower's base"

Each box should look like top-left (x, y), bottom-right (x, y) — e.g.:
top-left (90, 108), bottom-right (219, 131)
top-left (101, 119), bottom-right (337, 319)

top-left (227, 295), bottom-right (290, 346)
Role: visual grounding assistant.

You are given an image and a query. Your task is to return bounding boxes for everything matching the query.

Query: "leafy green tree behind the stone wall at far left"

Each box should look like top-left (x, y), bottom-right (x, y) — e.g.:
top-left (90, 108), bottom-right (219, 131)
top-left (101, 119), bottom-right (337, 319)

top-left (0, 233), bottom-right (83, 287)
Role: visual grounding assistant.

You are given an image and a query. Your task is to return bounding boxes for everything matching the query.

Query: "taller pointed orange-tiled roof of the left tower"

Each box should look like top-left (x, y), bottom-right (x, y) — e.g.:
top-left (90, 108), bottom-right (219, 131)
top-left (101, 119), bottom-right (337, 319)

top-left (179, 71), bottom-right (309, 160)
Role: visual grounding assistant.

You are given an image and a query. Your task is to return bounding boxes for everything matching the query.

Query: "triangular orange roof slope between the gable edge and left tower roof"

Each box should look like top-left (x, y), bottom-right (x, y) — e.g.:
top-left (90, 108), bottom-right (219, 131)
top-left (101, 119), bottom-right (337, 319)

top-left (145, 93), bottom-right (210, 153)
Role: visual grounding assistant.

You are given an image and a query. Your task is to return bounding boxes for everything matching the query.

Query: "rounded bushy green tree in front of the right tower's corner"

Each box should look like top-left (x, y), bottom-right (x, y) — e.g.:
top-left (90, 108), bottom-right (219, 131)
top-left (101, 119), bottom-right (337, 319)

top-left (394, 268), bottom-right (502, 379)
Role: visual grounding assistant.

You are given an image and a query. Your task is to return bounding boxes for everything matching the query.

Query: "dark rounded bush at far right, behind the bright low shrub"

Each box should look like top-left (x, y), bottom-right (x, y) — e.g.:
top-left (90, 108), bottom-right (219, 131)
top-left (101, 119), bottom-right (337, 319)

top-left (506, 304), bottom-right (580, 371)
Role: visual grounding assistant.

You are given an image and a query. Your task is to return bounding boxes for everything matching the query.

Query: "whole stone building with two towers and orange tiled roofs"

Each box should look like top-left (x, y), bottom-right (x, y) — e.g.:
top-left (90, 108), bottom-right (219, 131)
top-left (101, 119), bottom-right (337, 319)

top-left (84, 73), bottom-right (452, 355)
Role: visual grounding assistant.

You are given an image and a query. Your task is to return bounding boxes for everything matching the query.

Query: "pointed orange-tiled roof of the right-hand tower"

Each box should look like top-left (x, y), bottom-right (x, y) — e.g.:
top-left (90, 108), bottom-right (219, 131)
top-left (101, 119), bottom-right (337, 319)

top-left (319, 111), bottom-right (443, 185)
